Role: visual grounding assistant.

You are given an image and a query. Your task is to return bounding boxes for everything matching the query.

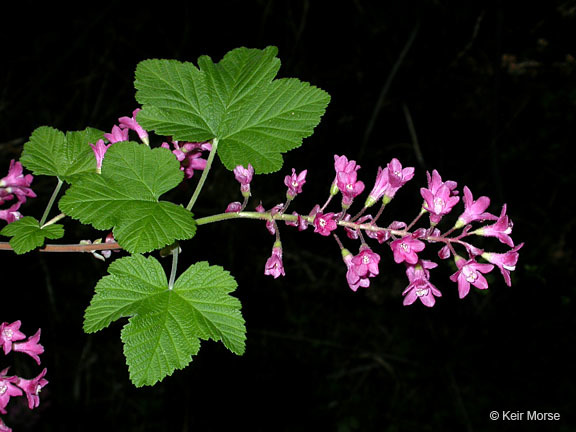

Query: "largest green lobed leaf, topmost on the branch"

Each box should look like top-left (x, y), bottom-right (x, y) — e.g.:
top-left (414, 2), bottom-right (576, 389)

top-left (135, 47), bottom-right (330, 173)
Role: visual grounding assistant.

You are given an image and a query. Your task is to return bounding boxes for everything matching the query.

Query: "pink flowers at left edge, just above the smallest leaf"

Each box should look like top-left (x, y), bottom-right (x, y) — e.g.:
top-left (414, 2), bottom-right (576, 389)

top-left (0, 160), bottom-right (36, 223)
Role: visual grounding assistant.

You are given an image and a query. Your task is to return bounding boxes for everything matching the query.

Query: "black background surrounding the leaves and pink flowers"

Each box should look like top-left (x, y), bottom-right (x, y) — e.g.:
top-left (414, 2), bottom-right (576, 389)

top-left (0, 0), bottom-right (576, 432)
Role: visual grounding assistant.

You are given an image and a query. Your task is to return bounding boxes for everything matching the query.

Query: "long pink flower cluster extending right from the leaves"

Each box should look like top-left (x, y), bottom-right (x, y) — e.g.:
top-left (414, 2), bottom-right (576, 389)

top-left (226, 155), bottom-right (523, 307)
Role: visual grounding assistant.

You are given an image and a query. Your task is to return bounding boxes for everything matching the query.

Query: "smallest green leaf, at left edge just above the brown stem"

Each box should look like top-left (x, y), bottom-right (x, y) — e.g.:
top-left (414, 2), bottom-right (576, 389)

top-left (0, 216), bottom-right (64, 255)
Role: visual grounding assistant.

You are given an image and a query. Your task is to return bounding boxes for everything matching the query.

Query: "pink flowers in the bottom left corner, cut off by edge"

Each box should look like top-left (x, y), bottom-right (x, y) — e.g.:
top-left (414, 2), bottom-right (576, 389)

top-left (0, 321), bottom-right (48, 431)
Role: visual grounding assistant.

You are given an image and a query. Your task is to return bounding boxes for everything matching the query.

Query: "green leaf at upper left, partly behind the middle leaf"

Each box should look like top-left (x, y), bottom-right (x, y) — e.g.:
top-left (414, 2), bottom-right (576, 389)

top-left (20, 126), bottom-right (104, 183)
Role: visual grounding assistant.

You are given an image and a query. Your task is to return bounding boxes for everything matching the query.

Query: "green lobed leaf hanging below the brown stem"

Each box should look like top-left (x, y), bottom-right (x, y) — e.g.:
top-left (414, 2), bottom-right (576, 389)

top-left (84, 255), bottom-right (246, 387)
